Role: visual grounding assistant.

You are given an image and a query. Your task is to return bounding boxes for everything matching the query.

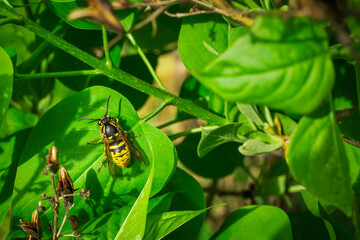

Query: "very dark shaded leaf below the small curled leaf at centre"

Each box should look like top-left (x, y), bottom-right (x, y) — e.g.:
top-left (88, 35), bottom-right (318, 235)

top-left (176, 134), bottom-right (243, 178)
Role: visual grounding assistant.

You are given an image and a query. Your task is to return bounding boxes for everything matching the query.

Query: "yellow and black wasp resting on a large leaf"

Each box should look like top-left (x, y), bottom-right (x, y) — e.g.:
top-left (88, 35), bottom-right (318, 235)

top-left (78, 96), bottom-right (144, 179)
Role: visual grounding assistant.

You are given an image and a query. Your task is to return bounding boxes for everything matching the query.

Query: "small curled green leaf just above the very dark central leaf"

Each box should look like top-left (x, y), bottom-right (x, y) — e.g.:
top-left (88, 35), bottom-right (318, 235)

top-left (197, 123), bottom-right (246, 158)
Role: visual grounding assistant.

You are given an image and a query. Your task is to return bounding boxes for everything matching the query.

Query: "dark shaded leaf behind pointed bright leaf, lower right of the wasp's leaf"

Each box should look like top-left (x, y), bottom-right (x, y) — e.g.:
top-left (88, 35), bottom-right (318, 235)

top-left (164, 168), bottom-right (205, 240)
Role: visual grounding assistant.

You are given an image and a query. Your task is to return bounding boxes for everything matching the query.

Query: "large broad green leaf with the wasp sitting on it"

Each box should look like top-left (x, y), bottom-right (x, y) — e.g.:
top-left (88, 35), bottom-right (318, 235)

top-left (12, 87), bottom-right (177, 237)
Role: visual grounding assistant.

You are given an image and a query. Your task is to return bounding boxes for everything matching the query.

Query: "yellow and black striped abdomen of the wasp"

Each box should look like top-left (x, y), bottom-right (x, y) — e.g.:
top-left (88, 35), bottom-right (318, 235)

top-left (109, 139), bottom-right (131, 168)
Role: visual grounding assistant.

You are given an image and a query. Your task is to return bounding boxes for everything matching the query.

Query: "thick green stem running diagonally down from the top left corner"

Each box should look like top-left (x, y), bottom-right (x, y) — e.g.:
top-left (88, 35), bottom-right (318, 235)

top-left (0, 2), bottom-right (227, 125)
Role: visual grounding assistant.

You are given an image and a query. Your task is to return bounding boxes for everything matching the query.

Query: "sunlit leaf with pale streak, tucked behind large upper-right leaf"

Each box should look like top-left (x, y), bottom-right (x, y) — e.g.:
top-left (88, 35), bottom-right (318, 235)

top-left (178, 14), bottom-right (228, 73)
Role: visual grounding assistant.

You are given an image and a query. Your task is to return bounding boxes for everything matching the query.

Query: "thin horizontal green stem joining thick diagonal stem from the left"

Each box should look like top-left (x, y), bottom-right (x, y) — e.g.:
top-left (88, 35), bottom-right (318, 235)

top-left (15, 70), bottom-right (101, 81)
